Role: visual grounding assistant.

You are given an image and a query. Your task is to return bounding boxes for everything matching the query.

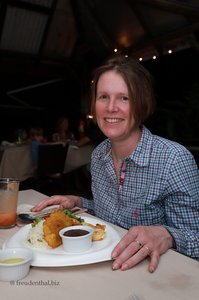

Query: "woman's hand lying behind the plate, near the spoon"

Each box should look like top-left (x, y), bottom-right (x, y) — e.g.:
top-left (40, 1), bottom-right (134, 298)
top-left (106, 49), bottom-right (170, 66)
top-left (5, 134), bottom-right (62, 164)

top-left (31, 195), bottom-right (81, 211)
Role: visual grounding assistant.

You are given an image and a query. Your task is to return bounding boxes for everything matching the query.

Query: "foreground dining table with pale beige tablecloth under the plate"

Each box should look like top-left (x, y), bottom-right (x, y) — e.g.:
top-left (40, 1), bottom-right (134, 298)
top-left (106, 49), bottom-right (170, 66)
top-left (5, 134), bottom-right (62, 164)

top-left (0, 190), bottom-right (199, 300)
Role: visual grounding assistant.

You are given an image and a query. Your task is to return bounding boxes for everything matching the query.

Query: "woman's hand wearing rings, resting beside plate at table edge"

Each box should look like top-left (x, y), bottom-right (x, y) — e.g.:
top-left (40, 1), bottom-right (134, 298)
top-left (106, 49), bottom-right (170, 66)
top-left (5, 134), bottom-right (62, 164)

top-left (112, 226), bottom-right (174, 273)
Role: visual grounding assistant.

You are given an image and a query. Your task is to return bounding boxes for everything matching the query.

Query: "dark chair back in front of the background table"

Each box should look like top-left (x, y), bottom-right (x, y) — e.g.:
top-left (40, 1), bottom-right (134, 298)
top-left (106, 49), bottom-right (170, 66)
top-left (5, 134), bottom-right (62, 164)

top-left (36, 144), bottom-right (68, 194)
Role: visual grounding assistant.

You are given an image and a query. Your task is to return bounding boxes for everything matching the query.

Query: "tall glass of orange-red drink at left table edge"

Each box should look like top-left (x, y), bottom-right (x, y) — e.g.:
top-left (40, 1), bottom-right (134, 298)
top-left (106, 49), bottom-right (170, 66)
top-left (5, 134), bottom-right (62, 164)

top-left (0, 178), bottom-right (19, 229)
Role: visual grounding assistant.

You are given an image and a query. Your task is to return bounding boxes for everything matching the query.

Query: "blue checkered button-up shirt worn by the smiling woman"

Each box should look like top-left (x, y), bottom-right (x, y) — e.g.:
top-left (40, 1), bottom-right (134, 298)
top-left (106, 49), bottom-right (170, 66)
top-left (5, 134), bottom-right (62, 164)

top-left (82, 126), bottom-right (199, 258)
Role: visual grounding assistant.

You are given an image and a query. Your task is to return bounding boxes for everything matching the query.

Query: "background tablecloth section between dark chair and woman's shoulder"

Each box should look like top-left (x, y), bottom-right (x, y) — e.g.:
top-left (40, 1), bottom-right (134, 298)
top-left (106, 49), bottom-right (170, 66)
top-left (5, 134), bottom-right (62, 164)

top-left (64, 145), bottom-right (94, 173)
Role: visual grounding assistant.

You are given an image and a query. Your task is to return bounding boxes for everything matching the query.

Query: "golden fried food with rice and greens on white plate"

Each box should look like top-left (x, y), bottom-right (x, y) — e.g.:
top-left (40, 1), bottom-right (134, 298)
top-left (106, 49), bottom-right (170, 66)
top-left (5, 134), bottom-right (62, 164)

top-left (27, 209), bottom-right (106, 248)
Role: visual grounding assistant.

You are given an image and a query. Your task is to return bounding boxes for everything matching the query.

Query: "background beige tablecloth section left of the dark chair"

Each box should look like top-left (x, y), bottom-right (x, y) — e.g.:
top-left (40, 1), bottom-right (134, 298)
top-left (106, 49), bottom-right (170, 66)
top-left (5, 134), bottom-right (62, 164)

top-left (0, 145), bottom-right (33, 181)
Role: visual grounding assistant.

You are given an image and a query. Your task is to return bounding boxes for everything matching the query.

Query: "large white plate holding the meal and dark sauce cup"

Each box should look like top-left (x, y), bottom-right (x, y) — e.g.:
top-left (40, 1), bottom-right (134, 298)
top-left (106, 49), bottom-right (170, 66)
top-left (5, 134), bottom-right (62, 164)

top-left (3, 217), bottom-right (121, 267)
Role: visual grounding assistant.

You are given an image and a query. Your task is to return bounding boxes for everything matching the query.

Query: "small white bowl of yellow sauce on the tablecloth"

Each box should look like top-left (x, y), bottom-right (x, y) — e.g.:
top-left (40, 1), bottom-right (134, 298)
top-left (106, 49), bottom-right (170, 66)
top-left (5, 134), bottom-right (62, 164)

top-left (0, 248), bottom-right (33, 281)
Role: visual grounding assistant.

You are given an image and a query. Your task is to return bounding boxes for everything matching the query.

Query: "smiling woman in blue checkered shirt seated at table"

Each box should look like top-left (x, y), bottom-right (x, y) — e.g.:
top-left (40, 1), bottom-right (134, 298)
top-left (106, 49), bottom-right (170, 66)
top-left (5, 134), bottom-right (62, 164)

top-left (34, 56), bottom-right (199, 272)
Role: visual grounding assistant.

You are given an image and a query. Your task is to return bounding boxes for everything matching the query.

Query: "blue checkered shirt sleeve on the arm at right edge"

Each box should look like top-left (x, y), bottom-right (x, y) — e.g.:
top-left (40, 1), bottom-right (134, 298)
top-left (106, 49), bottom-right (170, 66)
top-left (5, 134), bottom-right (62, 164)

top-left (164, 151), bottom-right (199, 258)
